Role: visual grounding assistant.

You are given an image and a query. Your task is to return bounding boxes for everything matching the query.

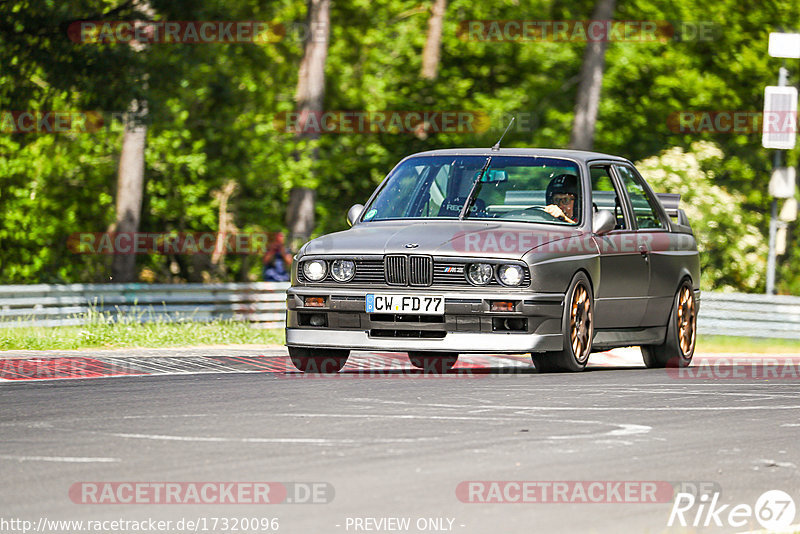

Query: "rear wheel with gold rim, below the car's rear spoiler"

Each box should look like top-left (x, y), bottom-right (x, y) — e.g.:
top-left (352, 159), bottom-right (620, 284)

top-left (641, 280), bottom-right (697, 369)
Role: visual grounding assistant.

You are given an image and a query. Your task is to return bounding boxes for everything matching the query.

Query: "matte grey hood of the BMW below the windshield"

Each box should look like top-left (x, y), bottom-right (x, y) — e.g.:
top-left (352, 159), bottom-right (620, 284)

top-left (301, 221), bottom-right (576, 259)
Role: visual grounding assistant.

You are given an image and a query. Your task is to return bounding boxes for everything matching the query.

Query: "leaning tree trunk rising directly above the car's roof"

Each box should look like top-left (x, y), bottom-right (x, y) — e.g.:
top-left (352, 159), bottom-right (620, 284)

top-left (569, 0), bottom-right (616, 150)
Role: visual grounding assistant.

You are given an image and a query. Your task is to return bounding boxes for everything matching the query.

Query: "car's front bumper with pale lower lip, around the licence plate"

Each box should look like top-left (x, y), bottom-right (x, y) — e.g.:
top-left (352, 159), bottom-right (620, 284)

top-left (286, 286), bottom-right (564, 353)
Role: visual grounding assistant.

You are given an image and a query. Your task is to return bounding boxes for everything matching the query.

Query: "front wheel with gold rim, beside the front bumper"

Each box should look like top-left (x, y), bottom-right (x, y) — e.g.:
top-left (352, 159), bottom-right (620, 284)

top-left (533, 272), bottom-right (594, 373)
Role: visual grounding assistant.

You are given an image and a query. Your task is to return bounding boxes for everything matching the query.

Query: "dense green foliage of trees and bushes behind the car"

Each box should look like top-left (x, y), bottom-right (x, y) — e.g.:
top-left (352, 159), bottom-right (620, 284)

top-left (0, 0), bottom-right (800, 292)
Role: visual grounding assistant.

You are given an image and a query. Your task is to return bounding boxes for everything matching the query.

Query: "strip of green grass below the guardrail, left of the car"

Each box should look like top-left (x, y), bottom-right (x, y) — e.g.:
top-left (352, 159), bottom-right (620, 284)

top-left (0, 312), bottom-right (284, 350)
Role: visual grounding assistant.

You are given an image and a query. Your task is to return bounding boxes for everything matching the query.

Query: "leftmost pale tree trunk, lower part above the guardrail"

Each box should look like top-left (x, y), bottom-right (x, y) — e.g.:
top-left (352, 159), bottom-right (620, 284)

top-left (111, 101), bottom-right (147, 283)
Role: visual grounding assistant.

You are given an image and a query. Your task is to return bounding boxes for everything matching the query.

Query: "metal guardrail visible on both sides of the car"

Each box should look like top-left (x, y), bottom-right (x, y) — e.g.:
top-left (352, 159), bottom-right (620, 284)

top-left (0, 282), bottom-right (800, 339)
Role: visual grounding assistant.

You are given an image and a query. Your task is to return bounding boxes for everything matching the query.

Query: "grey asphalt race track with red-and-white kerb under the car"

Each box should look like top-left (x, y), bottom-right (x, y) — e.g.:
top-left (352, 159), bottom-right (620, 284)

top-left (0, 348), bottom-right (800, 534)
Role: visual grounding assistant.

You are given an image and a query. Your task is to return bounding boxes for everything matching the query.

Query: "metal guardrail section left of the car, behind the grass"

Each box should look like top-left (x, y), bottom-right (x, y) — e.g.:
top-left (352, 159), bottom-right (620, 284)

top-left (0, 282), bottom-right (289, 328)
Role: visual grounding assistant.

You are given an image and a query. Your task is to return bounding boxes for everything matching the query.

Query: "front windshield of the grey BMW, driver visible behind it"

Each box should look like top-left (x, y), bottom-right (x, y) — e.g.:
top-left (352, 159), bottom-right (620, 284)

top-left (362, 156), bottom-right (582, 225)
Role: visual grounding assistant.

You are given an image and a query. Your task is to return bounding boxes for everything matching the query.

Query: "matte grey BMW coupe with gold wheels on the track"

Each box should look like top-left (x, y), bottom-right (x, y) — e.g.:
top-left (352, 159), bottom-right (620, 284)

top-left (286, 147), bottom-right (700, 372)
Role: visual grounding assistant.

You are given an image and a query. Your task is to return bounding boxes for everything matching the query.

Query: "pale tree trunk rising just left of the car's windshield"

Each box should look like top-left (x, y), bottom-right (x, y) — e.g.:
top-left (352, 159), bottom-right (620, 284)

top-left (286, 0), bottom-right (330, 243)
